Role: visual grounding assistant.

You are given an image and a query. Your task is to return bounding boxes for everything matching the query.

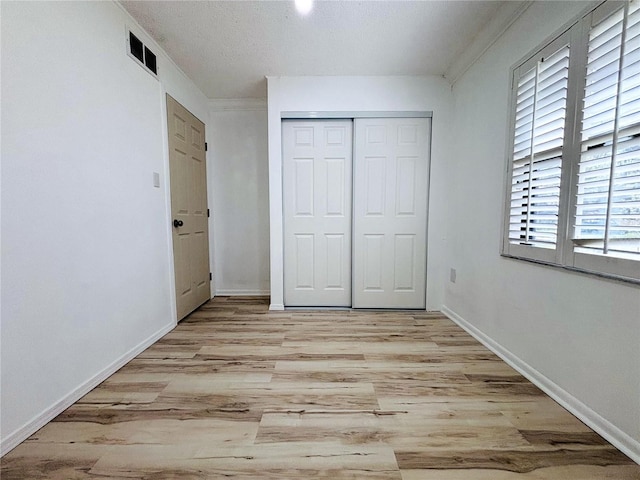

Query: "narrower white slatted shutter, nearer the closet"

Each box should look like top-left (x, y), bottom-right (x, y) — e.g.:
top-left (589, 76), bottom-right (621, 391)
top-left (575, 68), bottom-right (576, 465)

top-left (508, 36), bottom-right (569, 258)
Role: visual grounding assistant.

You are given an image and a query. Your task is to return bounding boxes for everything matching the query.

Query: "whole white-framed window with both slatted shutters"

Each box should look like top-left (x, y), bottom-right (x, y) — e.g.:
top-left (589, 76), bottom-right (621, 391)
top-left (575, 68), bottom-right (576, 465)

top-left (503, 0), bottom-right (640, 281)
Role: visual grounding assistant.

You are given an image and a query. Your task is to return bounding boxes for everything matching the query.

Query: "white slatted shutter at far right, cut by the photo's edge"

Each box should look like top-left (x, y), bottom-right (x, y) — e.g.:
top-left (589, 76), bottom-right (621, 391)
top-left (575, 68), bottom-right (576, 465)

top-left (574, 1), bottom-right (640, 256)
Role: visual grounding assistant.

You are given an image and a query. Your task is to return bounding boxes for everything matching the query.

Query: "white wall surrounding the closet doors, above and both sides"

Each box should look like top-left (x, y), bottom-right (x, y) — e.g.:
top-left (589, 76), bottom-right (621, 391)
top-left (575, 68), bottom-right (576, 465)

top-left (267, 76), bottom-right (451, 310)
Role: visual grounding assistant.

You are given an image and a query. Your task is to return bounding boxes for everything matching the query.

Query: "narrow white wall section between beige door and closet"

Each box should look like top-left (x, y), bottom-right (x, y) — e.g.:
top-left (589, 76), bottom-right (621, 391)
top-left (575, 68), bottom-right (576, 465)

top-left (207, 101), bottom-right (269, 295)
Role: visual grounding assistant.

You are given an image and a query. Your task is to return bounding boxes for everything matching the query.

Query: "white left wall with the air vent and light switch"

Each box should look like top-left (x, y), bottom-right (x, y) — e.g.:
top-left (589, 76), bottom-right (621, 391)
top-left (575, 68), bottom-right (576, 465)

top-left (0, 2), bottom-right (207, 452)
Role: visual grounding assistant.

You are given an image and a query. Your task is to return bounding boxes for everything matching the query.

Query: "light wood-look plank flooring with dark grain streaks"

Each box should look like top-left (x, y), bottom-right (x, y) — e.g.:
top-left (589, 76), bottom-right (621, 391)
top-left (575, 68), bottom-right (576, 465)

top-left (1, 297), bottom-right (640, 480)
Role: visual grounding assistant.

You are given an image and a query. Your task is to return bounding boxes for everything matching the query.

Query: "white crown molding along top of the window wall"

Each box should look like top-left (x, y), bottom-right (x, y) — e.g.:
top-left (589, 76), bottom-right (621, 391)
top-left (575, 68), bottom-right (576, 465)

top-left (444, 0), bottom-right (534, 85)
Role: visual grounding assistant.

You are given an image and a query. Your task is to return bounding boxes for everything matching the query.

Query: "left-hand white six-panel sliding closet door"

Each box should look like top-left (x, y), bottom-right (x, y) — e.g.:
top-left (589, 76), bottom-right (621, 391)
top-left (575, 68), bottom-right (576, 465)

top-left (282, 120), bottom-right (353, 307)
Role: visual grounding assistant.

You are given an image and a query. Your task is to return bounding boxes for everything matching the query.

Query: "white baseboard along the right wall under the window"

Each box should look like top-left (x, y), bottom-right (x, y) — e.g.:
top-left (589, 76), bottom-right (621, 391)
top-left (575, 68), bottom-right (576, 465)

top-left (442, 305), bottom-right (640, 464)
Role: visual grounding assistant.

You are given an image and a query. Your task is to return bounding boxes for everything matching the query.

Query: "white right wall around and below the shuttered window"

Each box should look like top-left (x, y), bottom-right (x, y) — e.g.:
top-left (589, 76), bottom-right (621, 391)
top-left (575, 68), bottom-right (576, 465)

top-left (444, 2), bottom-right (640, 461)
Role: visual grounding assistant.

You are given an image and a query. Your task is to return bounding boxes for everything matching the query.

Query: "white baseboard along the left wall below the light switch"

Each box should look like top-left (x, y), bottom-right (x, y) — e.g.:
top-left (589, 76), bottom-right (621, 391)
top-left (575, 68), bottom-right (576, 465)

top-left (0, 324), bottom-right (176, 457)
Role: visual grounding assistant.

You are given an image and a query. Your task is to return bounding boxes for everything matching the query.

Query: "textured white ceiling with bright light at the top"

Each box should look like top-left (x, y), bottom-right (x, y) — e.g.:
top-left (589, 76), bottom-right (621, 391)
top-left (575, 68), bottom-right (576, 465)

top-left (121, 0), bottom-right (505, 98)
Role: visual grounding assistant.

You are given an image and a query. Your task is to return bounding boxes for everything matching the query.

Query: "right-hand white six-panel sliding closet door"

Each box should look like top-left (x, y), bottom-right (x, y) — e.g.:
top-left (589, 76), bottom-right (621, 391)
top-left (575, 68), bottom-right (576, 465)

top-left (353, 118), bottom-right (431, 308)
